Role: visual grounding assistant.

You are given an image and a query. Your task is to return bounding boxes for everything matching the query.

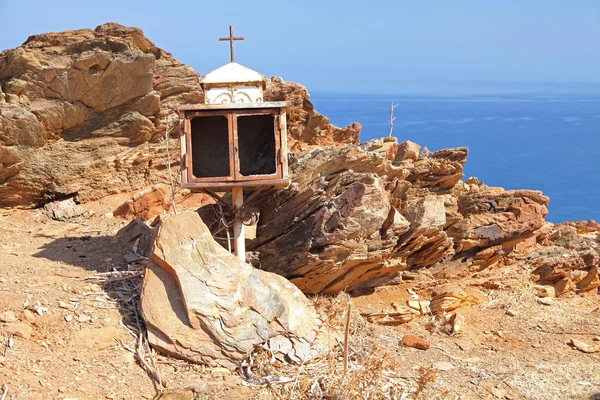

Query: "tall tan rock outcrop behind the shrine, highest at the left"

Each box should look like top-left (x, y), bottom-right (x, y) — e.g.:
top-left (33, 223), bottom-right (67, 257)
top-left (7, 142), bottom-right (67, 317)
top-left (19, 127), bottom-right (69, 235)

top-left (0, 23), bottom-right (360, 207)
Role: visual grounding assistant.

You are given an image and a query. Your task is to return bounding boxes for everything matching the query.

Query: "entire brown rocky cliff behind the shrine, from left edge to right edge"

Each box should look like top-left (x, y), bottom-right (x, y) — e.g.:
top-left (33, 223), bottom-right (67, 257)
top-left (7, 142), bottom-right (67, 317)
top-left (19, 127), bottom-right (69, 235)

top-left (0, 23), bottom-right (599, 293)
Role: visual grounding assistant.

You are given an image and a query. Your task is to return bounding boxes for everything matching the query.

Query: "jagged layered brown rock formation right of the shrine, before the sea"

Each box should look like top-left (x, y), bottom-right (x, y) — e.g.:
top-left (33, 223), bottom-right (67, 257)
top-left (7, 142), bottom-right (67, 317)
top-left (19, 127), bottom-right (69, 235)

top-left (246, 138), bottom-right (549, 293)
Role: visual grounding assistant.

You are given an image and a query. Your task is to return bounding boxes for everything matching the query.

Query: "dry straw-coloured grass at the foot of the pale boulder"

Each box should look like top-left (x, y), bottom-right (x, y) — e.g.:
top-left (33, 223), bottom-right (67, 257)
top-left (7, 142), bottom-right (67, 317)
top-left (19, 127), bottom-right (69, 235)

top-left (241, 293), bottom-right (412, 399)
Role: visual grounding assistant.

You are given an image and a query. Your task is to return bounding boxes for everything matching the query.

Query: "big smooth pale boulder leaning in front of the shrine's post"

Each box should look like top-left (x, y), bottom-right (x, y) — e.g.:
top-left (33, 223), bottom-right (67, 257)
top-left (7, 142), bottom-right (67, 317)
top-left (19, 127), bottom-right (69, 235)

top-left (142, 212), bottom-right (321, 369)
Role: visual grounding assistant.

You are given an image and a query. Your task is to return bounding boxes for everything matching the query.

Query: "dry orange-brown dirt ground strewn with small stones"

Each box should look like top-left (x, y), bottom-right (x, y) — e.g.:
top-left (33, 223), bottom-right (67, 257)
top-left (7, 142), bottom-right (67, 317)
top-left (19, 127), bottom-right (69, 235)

top-left (0, 195), bottom-right (600, 400)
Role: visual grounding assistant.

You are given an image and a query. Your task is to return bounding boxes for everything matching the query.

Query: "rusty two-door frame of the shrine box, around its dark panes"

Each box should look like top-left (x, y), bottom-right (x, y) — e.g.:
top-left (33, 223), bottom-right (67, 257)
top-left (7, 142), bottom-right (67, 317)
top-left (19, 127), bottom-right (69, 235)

top-left (178, 102), bottom-right (290, 189)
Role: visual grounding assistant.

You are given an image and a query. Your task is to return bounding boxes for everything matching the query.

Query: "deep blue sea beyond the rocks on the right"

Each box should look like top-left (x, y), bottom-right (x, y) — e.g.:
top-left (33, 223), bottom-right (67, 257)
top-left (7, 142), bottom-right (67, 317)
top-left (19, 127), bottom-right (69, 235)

top-left (311, 93), bottom-right (600, 223)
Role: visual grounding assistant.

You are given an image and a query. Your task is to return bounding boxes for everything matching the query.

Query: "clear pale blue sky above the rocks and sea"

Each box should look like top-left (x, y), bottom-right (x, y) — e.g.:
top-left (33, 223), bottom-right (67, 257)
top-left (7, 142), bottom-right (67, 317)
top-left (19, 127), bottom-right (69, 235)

top-left (0, 0), bottom-right (600, 92)
